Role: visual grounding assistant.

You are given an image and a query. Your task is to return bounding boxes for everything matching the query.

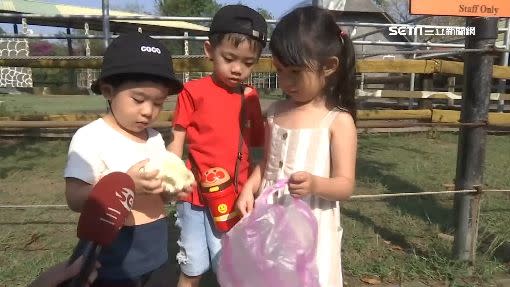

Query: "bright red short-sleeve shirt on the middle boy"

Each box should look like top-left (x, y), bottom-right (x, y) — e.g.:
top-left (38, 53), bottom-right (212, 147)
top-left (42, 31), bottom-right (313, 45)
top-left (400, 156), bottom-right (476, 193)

top-left (173, 76), bottom-right (264, 206)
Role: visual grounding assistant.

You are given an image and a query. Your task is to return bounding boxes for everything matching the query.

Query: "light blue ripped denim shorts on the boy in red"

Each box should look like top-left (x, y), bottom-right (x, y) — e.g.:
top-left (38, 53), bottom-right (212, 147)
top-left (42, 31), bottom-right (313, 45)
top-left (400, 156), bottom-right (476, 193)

top-left (175, 202), bottom-right (222, 276)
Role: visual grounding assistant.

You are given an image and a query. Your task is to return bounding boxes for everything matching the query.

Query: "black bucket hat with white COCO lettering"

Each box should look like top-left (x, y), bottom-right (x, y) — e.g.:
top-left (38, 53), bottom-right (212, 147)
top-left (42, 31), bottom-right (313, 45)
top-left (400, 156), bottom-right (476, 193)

top-left (90, 32), bottom-right (182, 94)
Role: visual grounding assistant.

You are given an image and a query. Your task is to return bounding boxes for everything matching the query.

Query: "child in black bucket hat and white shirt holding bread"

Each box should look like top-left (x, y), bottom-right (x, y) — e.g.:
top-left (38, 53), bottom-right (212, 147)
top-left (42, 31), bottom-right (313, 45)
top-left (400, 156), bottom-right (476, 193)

top-left (64, 32), bottom-right (186, 286)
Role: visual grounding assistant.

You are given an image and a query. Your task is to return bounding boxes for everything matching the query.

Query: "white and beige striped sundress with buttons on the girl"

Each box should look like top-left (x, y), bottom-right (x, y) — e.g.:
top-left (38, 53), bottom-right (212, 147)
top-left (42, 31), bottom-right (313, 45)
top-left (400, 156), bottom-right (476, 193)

top-left (260, 105), bottom-right (344, 287)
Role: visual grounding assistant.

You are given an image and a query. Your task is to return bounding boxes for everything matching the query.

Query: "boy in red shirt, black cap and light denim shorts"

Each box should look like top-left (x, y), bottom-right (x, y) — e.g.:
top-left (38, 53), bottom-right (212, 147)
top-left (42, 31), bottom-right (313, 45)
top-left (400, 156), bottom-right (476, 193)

top-left (168, 5), bottom-right (267, 287)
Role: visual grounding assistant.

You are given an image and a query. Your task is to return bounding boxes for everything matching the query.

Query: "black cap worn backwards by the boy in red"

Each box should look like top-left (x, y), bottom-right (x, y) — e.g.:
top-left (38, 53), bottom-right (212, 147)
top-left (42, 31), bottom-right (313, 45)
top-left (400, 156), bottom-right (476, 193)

top-left (209, 5), bottom-right (267, 47)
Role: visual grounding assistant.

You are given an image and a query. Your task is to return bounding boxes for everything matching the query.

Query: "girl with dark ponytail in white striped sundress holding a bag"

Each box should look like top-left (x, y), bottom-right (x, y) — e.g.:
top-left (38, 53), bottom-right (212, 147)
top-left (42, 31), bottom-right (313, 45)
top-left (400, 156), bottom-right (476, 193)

top-left (237, 7), bottom-right (357, 287)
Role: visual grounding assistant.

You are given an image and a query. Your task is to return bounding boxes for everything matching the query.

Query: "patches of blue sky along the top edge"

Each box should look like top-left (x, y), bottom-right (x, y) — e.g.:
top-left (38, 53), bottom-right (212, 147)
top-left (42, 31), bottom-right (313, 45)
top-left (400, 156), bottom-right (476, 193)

top-left (0, 0), bottom-right (300, 34)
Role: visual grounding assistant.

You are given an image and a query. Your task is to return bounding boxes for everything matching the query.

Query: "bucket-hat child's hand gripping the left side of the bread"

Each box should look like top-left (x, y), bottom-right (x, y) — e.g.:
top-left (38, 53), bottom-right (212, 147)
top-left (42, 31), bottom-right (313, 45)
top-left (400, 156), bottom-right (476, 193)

top-left (127, 159), bottom-right (164, 194)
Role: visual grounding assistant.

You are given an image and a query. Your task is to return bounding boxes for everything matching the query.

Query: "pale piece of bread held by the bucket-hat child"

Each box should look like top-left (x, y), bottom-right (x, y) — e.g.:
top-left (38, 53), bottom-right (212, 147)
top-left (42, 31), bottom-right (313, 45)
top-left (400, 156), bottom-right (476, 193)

top-left (142, 151), bottom-right (195, 193)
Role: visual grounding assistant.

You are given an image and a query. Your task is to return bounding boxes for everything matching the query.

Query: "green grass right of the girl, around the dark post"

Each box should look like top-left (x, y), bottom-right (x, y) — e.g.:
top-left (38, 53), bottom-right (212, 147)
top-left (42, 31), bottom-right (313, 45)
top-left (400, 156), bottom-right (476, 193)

top-left (342, 134), bottom-right (510, 286)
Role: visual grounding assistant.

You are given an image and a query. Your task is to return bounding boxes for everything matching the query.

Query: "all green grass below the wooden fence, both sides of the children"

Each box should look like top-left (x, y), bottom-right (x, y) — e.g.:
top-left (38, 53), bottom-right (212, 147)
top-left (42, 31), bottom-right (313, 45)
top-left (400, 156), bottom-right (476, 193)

top-left (0, 133), bottom-right (510, 286)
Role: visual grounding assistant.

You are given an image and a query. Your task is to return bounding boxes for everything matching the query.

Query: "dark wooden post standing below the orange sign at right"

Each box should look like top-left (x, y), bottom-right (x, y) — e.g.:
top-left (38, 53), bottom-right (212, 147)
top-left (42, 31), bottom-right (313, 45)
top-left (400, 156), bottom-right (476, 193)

top-left (453, 17), bottom-right (498, 261)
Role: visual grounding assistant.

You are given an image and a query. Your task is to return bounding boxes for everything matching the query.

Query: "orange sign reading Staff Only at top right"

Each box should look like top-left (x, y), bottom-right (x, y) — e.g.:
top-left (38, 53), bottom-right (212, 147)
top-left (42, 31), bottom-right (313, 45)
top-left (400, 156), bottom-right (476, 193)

top-left (409, 0), bottom-right (510, 18)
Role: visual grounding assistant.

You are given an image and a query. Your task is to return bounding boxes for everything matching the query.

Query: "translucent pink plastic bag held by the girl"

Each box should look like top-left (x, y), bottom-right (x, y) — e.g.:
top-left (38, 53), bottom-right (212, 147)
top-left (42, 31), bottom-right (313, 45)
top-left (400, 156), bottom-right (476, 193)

top-left (217, 180), bottom-right (319, 287)
